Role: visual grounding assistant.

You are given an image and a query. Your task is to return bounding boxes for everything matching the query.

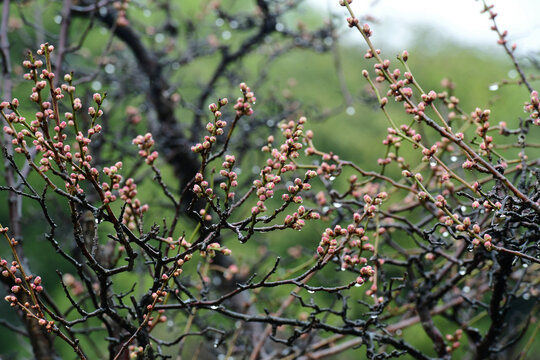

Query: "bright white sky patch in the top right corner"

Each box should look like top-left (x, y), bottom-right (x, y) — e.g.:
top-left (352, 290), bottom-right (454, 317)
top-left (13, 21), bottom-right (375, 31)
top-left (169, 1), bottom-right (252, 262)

top-left (308, 0), bottom-right (540, 53)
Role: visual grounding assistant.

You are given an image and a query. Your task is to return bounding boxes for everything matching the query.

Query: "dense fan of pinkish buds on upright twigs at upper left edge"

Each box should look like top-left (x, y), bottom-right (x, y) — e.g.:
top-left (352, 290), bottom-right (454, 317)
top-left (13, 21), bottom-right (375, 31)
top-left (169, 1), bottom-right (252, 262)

top-left (0, 44), bottom-right (116, 202)
